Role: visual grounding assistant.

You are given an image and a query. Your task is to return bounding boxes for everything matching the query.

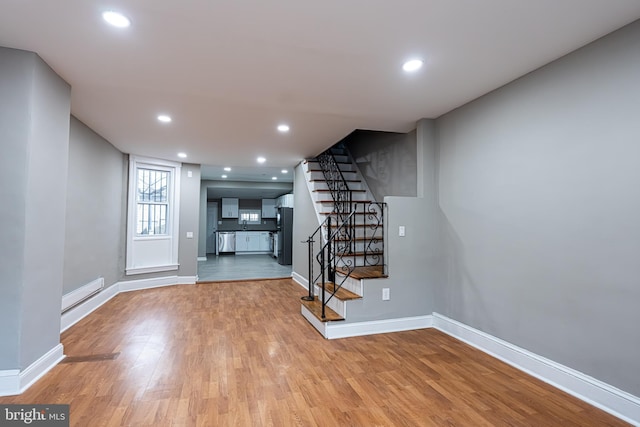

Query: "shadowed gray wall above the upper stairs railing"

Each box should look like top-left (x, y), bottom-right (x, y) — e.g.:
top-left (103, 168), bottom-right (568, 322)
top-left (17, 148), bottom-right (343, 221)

top-left (344, 130), bottom-right (417, 202)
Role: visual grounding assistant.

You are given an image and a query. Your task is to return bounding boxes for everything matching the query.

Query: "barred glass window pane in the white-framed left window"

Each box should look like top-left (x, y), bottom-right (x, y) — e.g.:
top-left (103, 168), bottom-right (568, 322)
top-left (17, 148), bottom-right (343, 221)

top-left (136, 168), bottom-right (169, 236)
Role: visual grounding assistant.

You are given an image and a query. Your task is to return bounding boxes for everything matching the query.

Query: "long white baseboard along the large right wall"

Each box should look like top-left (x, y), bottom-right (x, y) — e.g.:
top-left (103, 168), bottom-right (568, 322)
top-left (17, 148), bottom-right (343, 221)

top-left (433, 313), bottom-right (640, 426)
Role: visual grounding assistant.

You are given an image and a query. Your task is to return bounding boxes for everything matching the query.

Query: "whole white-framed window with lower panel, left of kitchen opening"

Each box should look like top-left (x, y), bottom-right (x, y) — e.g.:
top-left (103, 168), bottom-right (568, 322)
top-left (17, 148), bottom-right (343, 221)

top-left (126, 156), bottom-right (181, 275)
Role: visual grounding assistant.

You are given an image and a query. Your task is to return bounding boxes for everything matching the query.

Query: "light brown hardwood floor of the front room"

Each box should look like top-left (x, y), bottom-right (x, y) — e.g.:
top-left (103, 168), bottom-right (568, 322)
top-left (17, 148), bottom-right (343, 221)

top-left (0, 279), bottom-right (626, 427)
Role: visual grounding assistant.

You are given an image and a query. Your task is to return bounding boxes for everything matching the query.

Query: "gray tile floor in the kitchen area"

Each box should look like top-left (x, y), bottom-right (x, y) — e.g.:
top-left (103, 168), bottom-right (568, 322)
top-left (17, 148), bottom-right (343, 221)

top-left (198, 254), bottom-right (291, 282)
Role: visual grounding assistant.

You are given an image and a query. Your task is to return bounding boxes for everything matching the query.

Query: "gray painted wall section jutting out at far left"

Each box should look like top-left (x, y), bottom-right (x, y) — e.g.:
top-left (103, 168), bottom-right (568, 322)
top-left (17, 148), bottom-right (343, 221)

top-left (0, 48), bottom-right (71, 370)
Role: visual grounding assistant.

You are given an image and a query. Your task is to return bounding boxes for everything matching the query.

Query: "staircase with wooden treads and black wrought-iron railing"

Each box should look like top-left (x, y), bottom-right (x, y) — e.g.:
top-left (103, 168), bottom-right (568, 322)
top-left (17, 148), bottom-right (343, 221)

top-left (301, 144), bottom-right (387, 337)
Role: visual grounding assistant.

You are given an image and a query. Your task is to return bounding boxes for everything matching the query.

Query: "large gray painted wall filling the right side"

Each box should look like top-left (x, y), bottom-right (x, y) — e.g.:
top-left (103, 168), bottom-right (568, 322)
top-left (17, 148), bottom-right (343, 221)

top-left (436, 22), bottom-right (640, 396)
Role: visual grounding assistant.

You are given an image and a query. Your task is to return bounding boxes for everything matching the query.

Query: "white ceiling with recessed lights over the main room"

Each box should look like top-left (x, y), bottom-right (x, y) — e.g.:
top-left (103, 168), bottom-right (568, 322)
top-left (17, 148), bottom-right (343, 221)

top-left (0, 0), bottom-right (640, 180)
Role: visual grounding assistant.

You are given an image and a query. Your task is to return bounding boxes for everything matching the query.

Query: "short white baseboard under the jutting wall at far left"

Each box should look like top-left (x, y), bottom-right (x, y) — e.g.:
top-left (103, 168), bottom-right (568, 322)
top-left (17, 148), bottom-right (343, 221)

top-left (0, 344), bottom-right (64, 396)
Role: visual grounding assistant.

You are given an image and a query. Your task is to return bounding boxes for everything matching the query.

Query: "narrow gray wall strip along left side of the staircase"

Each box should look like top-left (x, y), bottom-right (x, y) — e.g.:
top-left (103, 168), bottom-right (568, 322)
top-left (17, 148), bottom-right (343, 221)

top-left (291, 160), bottom-right (320, 280)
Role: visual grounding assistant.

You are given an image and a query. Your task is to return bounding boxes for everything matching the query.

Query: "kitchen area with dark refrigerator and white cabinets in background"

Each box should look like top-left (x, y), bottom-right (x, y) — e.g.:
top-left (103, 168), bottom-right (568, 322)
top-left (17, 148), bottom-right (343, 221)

top-left (198, 193), bottom-right (293, 281)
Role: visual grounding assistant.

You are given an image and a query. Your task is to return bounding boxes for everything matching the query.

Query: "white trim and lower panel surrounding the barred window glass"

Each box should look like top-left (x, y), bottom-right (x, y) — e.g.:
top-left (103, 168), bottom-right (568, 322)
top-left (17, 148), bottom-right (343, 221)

top-left (125, 156), bottom-right (182, 275)
